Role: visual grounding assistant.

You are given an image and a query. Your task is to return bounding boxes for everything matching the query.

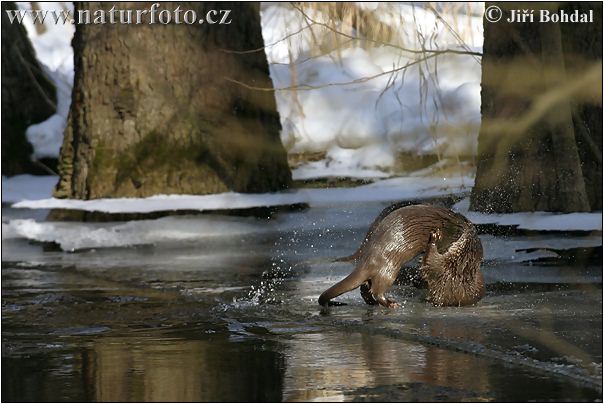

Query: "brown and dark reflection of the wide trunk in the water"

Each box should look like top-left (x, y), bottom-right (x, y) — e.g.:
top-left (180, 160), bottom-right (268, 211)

top-left (85, 338), bottom-right (281, 401)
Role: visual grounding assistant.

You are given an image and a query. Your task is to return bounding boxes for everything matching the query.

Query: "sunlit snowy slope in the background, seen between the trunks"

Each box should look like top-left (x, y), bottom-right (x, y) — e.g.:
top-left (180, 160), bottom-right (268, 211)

top-left (18, 2), bottom-right (484, 179)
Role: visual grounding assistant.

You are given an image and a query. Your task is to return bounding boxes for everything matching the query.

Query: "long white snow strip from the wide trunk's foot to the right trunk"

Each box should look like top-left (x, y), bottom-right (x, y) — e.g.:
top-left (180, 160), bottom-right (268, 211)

top-left (12, 177), bottom-right (473, 213)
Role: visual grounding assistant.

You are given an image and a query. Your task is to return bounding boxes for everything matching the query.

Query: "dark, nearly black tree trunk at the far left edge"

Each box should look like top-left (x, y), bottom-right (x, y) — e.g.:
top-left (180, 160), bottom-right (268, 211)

top-left (1, 2), bottom-right (56, 175)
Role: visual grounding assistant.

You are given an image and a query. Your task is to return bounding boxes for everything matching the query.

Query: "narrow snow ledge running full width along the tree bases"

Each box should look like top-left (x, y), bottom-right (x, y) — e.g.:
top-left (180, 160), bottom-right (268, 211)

top-left (2, 177), bottom-right (602, 231)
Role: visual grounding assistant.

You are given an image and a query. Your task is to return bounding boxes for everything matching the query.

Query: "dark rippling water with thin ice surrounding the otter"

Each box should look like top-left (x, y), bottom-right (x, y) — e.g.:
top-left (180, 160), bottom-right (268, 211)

top-left (2, 204), bottom-right (602, 401)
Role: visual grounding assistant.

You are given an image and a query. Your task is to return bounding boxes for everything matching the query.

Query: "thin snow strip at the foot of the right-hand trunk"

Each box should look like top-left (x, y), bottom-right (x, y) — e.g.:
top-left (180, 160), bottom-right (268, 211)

top-left (453, 198), bottom-right (602, 231)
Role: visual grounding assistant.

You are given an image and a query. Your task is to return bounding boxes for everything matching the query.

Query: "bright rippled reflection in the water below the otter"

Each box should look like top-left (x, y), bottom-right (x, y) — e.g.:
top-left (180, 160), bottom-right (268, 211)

top-left (284, 332), bottom-right (489, 401)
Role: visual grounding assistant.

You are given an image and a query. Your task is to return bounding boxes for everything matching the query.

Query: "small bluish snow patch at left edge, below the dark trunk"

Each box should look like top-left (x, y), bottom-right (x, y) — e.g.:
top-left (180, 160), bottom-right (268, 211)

top-left (2, 174), bottom-right (59, 203)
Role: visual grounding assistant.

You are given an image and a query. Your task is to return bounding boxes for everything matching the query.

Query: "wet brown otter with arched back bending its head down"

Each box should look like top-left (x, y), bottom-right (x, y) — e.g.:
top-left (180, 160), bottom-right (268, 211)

top-left (319, 204), bottom-right (485, 307)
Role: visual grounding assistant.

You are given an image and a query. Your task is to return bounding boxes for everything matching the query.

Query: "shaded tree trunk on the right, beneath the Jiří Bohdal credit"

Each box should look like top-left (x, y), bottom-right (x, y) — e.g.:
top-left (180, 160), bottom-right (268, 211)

top-left (471, 3), bottom-right (602, 212)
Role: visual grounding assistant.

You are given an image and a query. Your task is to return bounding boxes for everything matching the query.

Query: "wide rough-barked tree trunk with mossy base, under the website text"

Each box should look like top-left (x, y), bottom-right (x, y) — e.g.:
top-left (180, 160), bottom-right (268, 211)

top-left (55, 3), bottom-right (291, 199)
